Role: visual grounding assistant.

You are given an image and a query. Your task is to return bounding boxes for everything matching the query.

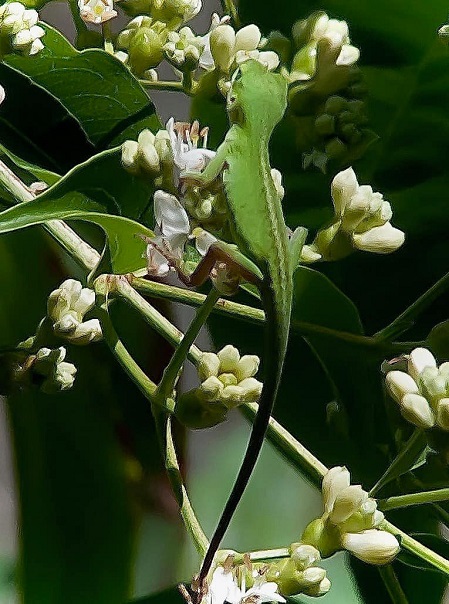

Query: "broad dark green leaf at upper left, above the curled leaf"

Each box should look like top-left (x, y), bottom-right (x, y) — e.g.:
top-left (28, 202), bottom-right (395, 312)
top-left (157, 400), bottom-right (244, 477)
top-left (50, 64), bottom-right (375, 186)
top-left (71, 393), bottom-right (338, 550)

top-left (4, 25), bottom-right (159, 149)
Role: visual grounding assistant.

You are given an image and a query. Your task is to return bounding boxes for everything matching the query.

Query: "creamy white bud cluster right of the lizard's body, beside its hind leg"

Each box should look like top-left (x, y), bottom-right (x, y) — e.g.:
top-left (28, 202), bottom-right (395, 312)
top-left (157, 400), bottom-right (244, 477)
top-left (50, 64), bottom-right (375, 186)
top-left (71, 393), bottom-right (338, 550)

top-left (302, 168), bottom-right (405, 263)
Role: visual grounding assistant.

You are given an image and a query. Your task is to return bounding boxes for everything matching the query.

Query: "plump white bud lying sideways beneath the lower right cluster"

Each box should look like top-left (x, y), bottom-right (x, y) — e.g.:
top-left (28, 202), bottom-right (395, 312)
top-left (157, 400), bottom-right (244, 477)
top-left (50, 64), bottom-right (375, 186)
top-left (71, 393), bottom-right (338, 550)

top-left (342, 529), bottom-right (400, 565)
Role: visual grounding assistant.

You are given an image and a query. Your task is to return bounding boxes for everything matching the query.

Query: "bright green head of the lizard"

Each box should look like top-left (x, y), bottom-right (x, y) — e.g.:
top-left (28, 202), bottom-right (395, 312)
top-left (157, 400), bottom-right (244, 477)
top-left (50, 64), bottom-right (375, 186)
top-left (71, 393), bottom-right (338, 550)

top-left (227, 59), bottom-right (287, 131)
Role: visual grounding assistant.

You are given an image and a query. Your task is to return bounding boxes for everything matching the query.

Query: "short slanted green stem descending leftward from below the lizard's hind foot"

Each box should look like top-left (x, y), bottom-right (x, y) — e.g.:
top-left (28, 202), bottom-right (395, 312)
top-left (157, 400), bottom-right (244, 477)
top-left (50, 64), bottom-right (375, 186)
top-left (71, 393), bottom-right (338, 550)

top-left (157, 287), bottom-right (220, 400)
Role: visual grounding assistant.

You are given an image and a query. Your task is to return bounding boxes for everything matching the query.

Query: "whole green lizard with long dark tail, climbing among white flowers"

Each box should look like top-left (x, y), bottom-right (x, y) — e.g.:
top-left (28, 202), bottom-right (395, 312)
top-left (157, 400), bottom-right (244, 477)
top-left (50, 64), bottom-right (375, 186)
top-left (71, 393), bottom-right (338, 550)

top-left (177, 60), bottom-right (305, 601)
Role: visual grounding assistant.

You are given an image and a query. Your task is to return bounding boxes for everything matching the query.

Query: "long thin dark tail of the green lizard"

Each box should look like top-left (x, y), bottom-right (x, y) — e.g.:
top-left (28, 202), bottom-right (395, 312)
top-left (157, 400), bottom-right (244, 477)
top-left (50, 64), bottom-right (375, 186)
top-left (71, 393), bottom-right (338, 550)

top-left (198, 287), bottom-right (290, 585)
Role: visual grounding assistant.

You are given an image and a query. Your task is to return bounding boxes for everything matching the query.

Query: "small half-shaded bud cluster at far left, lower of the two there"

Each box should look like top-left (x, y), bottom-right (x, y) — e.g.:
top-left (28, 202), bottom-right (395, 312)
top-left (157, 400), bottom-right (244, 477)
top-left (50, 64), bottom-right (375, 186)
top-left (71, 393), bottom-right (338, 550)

top-left (15, 346), bottom-right (76, 394)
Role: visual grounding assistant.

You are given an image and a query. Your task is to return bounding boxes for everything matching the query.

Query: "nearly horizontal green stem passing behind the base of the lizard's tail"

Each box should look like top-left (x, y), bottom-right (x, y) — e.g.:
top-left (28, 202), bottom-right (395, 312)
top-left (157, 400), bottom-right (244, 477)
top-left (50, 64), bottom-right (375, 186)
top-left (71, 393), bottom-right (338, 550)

top-left (132, 278), bottom-right (419, 354)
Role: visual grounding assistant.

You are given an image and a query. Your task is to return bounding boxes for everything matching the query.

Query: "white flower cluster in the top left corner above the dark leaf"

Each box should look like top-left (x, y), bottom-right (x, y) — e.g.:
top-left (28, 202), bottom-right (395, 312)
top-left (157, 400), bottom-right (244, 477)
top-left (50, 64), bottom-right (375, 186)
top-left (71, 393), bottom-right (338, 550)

top-left (0, 2), bottom-right (45, 56)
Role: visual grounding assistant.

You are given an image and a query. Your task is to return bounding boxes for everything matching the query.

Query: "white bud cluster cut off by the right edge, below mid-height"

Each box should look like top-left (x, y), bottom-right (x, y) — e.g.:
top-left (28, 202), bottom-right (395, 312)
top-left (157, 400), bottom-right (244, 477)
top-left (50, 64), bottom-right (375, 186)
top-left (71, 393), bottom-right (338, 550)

top-left (386, 348), bottom-right (449, 431)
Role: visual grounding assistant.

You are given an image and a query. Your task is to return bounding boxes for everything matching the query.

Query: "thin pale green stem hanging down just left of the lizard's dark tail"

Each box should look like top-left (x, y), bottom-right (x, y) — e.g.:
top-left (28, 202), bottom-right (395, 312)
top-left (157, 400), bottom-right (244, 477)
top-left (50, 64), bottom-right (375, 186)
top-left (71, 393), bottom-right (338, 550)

top-left (153, 405), bottom-right (209, 558)
